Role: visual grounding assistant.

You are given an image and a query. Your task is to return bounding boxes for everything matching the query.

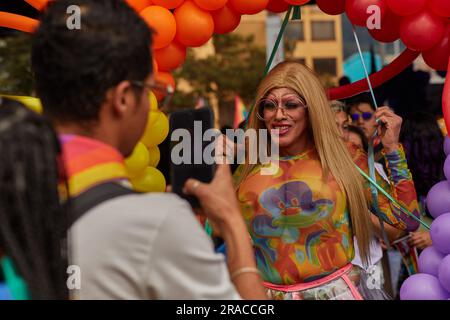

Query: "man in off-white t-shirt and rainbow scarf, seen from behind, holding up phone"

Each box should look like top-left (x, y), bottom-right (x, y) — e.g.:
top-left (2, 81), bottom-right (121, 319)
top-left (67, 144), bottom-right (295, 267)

top-left (32, 0), bottom-right (265, 299)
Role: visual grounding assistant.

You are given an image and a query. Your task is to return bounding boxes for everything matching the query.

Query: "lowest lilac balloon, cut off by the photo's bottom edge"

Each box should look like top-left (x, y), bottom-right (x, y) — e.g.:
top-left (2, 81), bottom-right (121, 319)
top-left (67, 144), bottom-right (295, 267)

top-left (400, 273), bottom-right (450, 300)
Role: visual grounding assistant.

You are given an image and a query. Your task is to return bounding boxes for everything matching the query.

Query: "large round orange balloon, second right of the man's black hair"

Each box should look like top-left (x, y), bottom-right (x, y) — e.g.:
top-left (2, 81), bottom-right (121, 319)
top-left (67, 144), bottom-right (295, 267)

top-left (174, 1), bottom-right (214, 47)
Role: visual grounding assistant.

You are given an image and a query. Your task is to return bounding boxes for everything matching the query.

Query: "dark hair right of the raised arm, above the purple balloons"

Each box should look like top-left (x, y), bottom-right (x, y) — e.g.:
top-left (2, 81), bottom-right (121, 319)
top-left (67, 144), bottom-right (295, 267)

top-left (400, 112), bottom-right (445, 196)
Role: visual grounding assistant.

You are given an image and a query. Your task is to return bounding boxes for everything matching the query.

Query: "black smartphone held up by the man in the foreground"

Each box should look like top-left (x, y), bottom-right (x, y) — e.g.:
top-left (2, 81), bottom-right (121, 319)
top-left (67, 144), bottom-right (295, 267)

top-left (169, 108), bottom-right (215, 208)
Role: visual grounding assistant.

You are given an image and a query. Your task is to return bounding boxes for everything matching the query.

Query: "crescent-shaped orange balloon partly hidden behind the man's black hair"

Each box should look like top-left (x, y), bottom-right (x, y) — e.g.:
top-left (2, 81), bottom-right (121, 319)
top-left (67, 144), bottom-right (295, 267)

top-left (141, 6), bottom-right (177, 49)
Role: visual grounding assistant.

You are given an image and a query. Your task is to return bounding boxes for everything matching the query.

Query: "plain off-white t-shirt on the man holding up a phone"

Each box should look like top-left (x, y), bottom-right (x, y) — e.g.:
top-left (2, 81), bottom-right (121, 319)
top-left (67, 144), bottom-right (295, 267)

top-left (70, 193), bottom-right (240, 300)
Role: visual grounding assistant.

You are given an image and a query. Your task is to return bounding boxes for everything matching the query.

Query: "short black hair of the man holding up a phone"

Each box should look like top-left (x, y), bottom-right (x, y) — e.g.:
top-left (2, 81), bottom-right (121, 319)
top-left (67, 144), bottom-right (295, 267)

top-left (32, 0), bottom-right (153, 122)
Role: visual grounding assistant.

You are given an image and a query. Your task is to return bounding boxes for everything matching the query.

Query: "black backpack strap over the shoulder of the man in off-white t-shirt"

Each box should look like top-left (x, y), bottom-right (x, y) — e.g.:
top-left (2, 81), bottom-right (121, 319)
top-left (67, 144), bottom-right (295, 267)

top-left (69, 182), bottom-right (137, 228)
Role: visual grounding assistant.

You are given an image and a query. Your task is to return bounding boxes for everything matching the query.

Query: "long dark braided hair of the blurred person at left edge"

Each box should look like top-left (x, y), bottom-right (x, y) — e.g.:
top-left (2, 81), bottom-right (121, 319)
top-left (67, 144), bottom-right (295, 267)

top-left (0, 98), bottom-right (68, 299)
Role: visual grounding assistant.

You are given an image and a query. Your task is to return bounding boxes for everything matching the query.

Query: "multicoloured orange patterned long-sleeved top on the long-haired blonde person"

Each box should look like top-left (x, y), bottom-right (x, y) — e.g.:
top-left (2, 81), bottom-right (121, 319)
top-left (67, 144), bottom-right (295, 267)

top-left (236, 145), bottom-right (419, 285)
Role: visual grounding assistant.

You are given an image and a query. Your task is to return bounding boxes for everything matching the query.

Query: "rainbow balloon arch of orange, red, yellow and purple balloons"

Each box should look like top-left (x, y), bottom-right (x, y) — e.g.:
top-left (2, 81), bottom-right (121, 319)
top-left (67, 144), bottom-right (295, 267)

top-left (0, 0), bottom-right (450, 299)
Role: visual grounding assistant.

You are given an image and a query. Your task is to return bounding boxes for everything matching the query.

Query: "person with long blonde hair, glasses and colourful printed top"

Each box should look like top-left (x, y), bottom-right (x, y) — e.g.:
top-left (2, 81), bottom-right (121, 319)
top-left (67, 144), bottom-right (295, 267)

top-left (236, 62), bottom-right (419, 299)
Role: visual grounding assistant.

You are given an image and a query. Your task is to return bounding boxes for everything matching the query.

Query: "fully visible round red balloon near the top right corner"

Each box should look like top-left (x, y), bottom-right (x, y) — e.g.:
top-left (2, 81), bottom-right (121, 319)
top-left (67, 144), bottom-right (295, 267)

top-left (400, 11), bottom-right (445, 51)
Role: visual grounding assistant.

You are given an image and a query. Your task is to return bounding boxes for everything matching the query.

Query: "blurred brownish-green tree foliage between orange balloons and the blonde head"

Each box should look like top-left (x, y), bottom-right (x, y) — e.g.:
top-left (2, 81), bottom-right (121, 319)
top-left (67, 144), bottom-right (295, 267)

top-left (174, 34), bottom-right (266, 113)
